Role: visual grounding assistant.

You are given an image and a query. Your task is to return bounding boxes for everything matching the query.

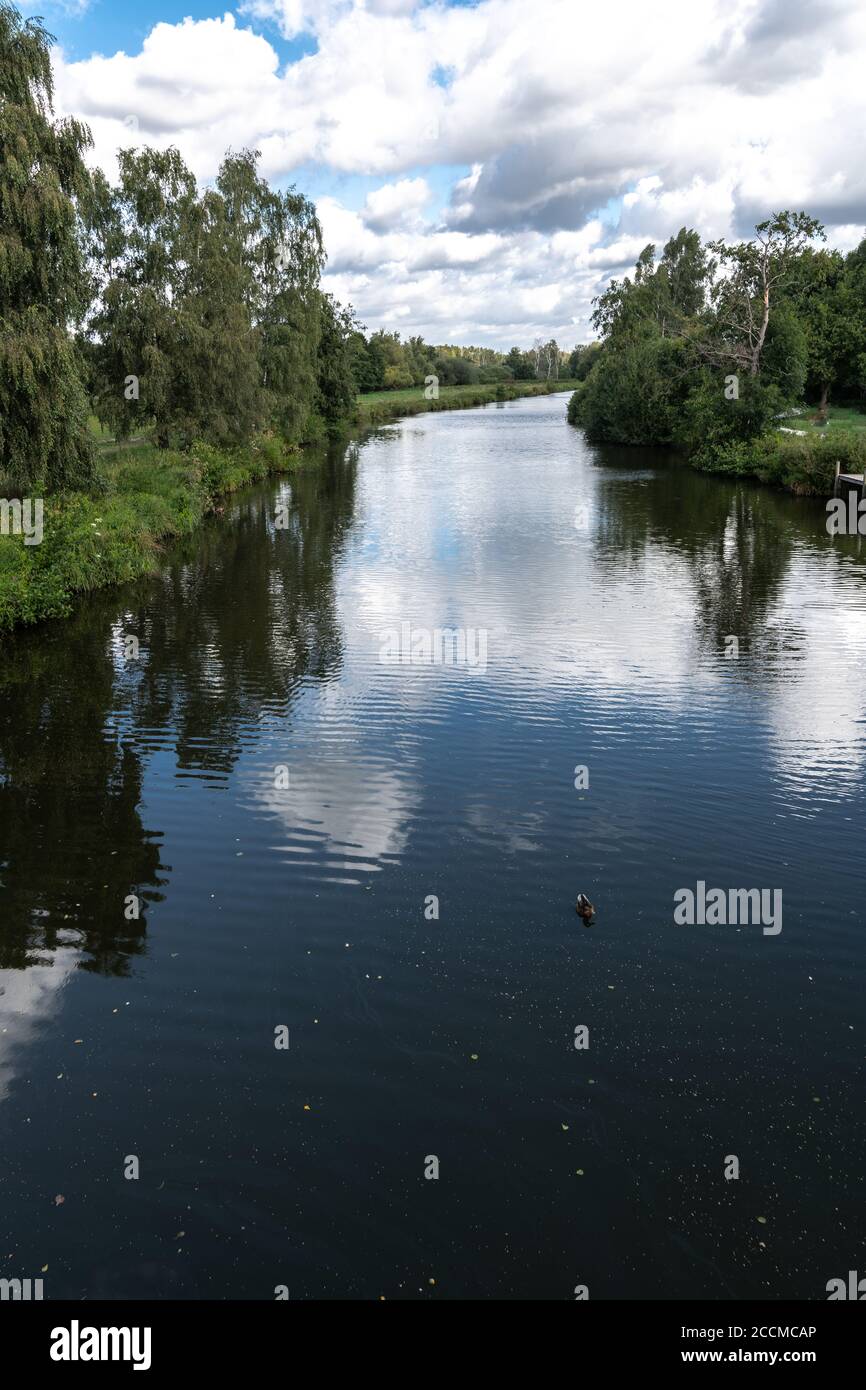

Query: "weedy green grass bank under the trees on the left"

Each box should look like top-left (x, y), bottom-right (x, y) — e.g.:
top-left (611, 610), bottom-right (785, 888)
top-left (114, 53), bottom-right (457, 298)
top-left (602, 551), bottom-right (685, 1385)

top-left (0, 438), bottom-right (311, 632)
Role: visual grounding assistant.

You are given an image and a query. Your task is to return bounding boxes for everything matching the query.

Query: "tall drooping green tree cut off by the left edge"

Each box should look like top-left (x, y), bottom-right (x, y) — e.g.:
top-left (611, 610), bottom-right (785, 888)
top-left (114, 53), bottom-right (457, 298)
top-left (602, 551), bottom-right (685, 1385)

top-left (0, 3), bottom-right (95, 489)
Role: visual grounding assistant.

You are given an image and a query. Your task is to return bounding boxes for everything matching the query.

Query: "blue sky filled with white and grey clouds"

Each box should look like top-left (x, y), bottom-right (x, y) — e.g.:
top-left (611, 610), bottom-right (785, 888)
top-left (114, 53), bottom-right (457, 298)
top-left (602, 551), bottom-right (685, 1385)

top-left (19, 0), bottom-right (866, 349)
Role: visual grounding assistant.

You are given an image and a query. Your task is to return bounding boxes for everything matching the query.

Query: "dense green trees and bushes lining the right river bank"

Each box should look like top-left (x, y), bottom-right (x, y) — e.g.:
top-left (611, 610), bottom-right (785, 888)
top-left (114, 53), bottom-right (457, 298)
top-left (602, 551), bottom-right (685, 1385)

top-left (569, 211), bottom-right (866, 467)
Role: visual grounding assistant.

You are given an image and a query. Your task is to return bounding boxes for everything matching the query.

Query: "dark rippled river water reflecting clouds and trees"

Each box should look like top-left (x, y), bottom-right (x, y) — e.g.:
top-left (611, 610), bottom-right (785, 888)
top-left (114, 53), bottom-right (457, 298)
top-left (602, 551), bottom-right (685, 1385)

top-left (0, 396), bottom-right (866, 1300)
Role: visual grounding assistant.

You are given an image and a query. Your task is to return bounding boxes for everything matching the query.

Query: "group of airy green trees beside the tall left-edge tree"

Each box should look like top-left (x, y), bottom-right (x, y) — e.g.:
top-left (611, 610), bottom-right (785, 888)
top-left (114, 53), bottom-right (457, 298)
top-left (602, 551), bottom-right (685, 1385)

top-left (88, 147), bottom-right (324, 445)
